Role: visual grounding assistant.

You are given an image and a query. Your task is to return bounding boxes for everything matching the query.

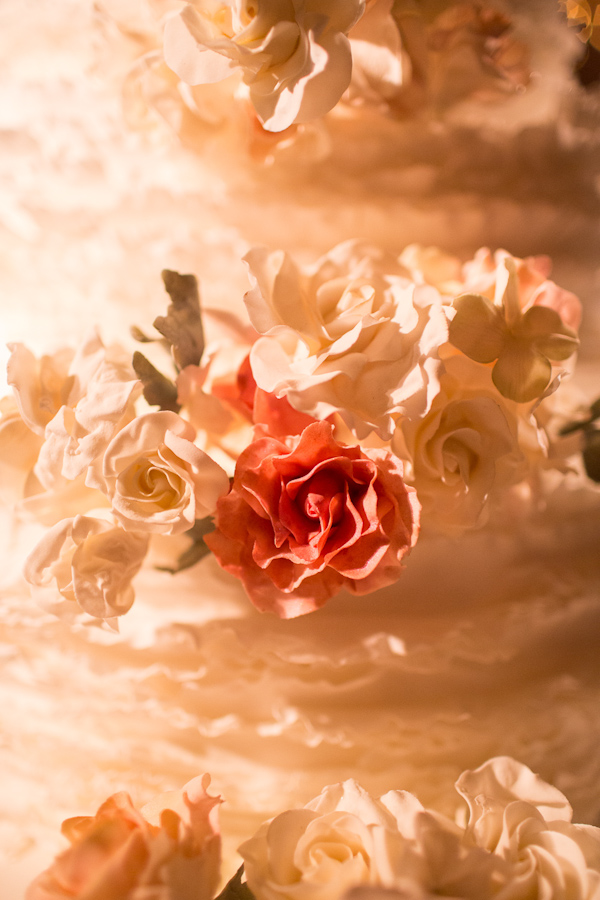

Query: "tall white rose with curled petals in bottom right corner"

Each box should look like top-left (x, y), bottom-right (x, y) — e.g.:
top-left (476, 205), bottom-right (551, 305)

top-left (456, 757), bottom-right (600, 900)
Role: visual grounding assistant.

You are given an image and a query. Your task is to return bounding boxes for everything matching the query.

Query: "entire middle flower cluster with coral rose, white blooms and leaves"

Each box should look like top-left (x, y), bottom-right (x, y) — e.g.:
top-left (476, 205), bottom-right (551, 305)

top-left (0, 241), bottom-right (580, 619)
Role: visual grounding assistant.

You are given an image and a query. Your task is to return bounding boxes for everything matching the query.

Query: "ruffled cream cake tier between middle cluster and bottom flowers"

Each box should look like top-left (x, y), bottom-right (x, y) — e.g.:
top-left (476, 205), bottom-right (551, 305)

top-left (1, 487), bottom-right (600, 868)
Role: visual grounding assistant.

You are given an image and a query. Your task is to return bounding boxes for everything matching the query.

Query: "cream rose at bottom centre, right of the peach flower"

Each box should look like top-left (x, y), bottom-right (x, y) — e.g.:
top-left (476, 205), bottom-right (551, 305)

top-left (239, 780), bottom-right (422, 900)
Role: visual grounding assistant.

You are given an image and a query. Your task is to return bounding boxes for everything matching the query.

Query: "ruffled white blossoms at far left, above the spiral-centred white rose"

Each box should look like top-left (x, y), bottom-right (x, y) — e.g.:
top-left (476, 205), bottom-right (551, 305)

top-left (8, 332), bottom-right (141, 490)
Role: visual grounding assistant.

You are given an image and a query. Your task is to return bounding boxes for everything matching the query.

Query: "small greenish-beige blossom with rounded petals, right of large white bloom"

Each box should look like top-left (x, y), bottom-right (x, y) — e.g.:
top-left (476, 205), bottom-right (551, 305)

top-left (449, 257), bottom-right (578, 403)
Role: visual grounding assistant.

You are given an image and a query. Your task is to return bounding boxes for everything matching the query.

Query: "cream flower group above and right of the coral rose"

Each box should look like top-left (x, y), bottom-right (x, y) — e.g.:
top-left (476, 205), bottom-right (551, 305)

top-left (246, 242), bottom-right (580, 534)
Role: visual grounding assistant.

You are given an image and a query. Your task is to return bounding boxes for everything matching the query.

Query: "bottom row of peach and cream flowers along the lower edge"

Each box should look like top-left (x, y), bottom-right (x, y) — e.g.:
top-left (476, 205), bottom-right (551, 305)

top-left (27, 757), bottom-right (600, 900)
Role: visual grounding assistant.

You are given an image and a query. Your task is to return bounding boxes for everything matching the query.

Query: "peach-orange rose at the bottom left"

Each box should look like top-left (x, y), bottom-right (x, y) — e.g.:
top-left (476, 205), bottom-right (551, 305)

top-left (26, 775), bottom-right (221, 900)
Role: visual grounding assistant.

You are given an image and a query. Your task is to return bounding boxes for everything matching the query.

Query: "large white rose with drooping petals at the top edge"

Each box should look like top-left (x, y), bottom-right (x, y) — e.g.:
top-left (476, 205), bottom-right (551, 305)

top-left (164, 0), bottom-right (364, 131)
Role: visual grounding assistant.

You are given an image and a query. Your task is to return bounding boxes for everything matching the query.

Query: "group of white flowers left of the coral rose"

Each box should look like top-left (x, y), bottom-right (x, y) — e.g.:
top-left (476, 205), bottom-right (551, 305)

top-left (0, 274), bottom-right (229, 624)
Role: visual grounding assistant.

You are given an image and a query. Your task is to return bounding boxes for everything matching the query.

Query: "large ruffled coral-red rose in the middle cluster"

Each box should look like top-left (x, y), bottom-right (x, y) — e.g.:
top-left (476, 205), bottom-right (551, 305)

top-left (206, 422), bottom-right (419, 619)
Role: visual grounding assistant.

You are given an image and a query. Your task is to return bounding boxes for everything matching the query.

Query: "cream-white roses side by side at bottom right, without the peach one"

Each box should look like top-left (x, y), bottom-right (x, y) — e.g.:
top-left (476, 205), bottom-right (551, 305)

top-left (239, 757), bottom-right (600, 900)
